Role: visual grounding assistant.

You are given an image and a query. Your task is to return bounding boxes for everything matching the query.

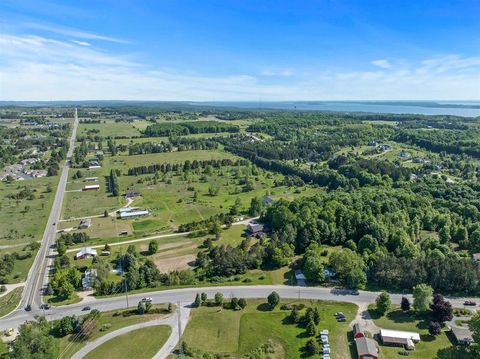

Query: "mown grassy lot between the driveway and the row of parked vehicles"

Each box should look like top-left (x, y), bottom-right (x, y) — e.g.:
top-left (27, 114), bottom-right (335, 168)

top-left (183, 300), bottom-right (357, 358)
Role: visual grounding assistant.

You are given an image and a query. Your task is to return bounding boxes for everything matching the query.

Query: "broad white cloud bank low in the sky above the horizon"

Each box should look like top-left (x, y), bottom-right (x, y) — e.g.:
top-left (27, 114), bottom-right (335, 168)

top-left (0, 34), bottom-right (480, 101)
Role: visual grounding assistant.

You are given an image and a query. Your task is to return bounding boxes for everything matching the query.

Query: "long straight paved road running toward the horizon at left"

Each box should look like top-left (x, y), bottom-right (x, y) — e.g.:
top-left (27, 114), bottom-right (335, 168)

top-left (20, 109), bottom-right (78, 309)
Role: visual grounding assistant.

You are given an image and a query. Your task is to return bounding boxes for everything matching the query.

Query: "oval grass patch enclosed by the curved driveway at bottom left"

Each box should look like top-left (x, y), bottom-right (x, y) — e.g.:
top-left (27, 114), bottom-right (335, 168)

top-left (85, 325), bottom-right (172, 359)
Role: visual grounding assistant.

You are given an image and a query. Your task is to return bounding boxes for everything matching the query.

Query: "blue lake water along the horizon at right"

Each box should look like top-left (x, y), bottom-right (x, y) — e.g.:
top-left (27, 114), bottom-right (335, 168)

top-left (192, 101), bottom-right (480, 117)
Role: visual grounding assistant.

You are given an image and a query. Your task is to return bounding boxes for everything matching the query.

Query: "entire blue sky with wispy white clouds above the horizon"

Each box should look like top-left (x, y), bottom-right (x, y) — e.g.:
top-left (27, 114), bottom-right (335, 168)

top-left (0, 0), bottom-right (480, 101)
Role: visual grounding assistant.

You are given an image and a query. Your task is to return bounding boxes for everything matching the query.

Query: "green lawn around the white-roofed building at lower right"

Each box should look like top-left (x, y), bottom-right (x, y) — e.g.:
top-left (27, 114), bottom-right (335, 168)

top-left (370, 306), bottom-right (453, 359)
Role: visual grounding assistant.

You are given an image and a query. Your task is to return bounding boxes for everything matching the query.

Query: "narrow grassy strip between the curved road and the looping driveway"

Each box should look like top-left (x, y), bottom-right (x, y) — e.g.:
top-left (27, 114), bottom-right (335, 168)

top-left (56, 305), bottom-right (171, 359)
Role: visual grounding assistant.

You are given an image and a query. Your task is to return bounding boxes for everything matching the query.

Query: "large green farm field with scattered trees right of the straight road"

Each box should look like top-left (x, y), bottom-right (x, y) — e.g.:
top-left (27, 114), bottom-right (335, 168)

top-left (62, 146), bottom-right (319, 239)
